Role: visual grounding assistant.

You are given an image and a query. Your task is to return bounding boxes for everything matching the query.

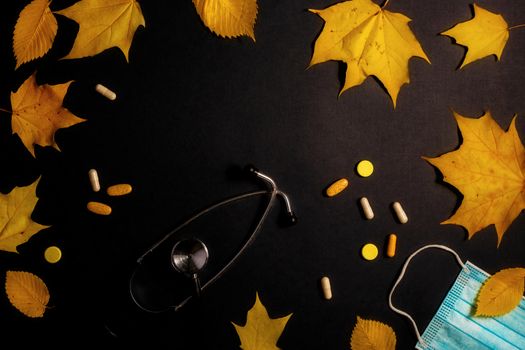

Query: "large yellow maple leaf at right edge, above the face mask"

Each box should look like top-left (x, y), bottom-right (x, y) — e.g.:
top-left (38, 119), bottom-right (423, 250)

top-left (423, 112), bottom-right (525, 246)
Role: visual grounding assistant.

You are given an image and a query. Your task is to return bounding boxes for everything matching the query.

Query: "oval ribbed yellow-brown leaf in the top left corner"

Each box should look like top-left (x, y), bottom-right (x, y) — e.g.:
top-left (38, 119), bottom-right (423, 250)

top-left (13, 0), bottom-right (58, 68)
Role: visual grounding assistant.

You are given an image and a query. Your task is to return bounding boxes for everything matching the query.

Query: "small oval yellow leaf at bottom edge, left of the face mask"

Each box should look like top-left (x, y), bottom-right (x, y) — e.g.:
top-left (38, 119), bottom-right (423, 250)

top-left (350, 316), bottom-right (396, 350)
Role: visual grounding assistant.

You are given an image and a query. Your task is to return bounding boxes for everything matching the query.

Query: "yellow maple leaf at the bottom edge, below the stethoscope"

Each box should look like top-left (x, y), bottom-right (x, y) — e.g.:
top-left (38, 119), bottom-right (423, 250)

top-left (232, 294), bottom-right (292, 350)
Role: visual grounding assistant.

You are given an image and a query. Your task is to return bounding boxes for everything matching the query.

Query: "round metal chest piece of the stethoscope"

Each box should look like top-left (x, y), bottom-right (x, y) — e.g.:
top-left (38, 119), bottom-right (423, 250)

top-left (171, 238), bottom-right (209, 295)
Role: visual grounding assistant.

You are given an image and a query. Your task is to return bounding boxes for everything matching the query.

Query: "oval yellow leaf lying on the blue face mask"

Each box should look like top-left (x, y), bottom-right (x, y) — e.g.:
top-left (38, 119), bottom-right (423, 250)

top-left (475, 267), bottom-right (525, 317)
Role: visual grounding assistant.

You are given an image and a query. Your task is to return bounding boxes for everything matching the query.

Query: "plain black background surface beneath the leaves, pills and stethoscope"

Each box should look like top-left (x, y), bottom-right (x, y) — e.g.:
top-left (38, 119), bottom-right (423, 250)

top-left (0, 0), bottom-right (525, 349)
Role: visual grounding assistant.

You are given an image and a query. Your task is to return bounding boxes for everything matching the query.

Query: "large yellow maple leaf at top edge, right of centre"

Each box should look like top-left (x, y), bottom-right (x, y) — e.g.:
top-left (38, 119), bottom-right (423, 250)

top-left (310, 0), bottom-right (430, 107)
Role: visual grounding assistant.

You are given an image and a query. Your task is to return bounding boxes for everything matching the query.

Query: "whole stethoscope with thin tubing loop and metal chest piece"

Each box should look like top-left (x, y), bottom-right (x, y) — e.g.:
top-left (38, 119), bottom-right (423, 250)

top-left (129, 165), bottom-right (297, 313)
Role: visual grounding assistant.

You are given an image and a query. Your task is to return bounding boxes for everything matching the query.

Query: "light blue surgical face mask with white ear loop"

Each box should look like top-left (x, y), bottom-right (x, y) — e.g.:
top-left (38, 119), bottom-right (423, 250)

top-left (388, 245), bottom-right (525, 350)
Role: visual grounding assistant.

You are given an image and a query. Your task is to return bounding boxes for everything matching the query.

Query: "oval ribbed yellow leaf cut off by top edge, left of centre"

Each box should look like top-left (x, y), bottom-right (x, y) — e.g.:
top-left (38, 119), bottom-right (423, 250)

top-left (193, 0), bottom-right (257, 41)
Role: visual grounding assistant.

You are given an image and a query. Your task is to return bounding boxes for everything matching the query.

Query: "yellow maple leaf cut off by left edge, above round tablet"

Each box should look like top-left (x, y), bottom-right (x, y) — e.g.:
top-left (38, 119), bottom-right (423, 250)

top-left (0, 180), bottom-right (49, 253)
